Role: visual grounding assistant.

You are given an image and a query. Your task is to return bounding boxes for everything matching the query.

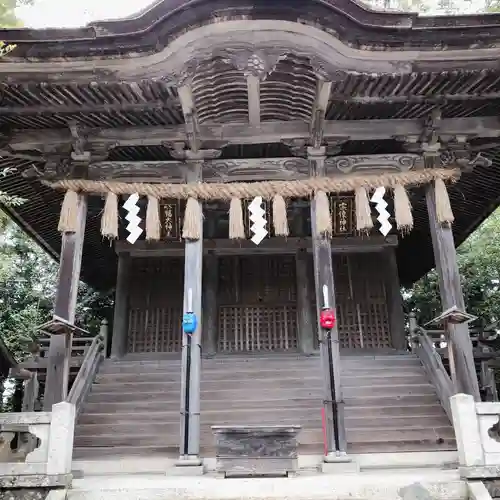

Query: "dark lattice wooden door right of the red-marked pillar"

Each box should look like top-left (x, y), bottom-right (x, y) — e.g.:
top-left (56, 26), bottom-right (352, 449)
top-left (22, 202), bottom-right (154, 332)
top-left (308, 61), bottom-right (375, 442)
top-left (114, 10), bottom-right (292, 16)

top-left (311, 253), bottom-right (391, 349)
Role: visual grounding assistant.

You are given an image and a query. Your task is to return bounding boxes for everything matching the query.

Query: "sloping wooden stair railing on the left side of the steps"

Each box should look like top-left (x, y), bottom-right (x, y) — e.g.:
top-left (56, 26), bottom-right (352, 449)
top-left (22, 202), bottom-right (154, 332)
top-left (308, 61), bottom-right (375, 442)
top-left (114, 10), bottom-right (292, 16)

top-left (66, 321), bottom-right (108, 415)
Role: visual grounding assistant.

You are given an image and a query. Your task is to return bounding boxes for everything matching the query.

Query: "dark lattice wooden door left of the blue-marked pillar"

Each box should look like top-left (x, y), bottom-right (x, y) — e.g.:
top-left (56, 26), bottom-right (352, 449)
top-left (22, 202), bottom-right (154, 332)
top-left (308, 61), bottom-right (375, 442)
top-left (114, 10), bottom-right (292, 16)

top-left (128, 257), bottom-right (184, 353)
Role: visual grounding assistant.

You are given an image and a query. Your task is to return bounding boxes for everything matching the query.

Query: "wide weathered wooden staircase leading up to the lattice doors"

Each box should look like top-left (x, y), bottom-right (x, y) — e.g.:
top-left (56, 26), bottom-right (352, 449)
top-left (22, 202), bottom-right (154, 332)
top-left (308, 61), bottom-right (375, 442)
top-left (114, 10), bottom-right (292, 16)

top-left (74, 354), bottom-right (455, 459)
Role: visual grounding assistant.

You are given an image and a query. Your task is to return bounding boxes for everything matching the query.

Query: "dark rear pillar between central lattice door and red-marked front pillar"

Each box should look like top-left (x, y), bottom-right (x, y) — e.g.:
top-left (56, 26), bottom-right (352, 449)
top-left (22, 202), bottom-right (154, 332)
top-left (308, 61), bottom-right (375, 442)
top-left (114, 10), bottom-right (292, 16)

top-left (295, 249), bottom-right (314, 354)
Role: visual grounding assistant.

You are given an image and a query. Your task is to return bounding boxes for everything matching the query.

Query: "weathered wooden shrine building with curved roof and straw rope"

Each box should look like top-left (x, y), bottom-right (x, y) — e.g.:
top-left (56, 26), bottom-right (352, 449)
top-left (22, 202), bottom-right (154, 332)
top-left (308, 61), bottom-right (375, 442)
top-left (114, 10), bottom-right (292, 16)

top-left (0, 0), bottom-right (500, 468)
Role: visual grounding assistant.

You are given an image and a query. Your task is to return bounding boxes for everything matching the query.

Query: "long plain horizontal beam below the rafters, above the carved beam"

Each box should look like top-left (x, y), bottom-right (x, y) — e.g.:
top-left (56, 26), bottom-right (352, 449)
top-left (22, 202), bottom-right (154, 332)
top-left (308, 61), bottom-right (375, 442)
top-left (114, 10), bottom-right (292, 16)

top-left (9, 116), bottom-right (500, 151)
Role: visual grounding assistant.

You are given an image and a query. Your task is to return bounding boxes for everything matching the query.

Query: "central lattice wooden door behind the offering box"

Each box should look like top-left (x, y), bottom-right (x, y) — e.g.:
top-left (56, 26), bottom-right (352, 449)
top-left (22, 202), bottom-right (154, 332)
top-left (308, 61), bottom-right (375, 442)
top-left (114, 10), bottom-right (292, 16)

top-left (219, 255), bottom-right (297, 352)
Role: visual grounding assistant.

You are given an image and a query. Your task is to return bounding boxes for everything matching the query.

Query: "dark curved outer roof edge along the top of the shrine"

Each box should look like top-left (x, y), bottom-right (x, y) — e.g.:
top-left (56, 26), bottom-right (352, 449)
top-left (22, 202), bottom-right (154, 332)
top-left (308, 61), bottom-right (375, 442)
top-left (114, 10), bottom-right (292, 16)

top-left (2, 0), bottom-right (500, 59)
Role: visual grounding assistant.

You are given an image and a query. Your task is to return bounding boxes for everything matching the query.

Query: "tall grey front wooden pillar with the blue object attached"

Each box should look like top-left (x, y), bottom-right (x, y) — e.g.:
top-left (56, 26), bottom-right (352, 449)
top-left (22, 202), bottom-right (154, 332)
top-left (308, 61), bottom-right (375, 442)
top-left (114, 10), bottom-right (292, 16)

top-left (179, 161), bottom-right (203, 465)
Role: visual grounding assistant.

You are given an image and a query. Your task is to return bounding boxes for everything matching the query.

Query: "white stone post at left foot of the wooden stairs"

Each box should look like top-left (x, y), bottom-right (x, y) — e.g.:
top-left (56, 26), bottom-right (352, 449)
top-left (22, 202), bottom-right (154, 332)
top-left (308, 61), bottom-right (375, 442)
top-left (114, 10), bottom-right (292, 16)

top-left (47, 401), bottom-right (76, 476)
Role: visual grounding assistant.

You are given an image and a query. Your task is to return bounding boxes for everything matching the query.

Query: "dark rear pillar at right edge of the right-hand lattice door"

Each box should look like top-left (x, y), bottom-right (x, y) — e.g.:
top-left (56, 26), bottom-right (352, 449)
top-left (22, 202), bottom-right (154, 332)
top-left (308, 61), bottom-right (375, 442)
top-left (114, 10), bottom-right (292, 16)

top-left (384, 247), bottom-right (408, 351)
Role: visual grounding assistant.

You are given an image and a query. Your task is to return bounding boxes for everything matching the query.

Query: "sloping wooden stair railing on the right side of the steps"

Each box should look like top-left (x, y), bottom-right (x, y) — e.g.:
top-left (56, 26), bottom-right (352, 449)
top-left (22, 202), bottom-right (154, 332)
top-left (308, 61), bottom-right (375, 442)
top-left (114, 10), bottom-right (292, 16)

top-left (410, 315), bottom-right (455, 421)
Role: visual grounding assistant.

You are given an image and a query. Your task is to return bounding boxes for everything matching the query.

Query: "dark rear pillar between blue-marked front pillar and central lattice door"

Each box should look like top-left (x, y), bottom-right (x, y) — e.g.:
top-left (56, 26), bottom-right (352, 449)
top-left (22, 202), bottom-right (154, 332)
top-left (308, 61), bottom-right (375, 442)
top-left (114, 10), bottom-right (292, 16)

top-left (203, 253), bottom-right (219, 356)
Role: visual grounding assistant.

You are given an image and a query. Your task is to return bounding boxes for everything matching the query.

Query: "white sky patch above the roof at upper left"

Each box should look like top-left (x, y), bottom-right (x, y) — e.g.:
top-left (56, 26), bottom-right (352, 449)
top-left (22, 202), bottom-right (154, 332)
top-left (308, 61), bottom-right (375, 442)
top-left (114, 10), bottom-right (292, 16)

top-left (16, 0), bottom-right (153, 28)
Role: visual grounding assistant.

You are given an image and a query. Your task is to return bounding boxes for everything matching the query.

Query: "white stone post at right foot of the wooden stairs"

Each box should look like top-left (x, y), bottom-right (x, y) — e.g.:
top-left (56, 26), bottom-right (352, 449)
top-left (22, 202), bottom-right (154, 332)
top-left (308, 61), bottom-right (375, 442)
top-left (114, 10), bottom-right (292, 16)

top-left (450, 394), bottom-right (484, 467)
